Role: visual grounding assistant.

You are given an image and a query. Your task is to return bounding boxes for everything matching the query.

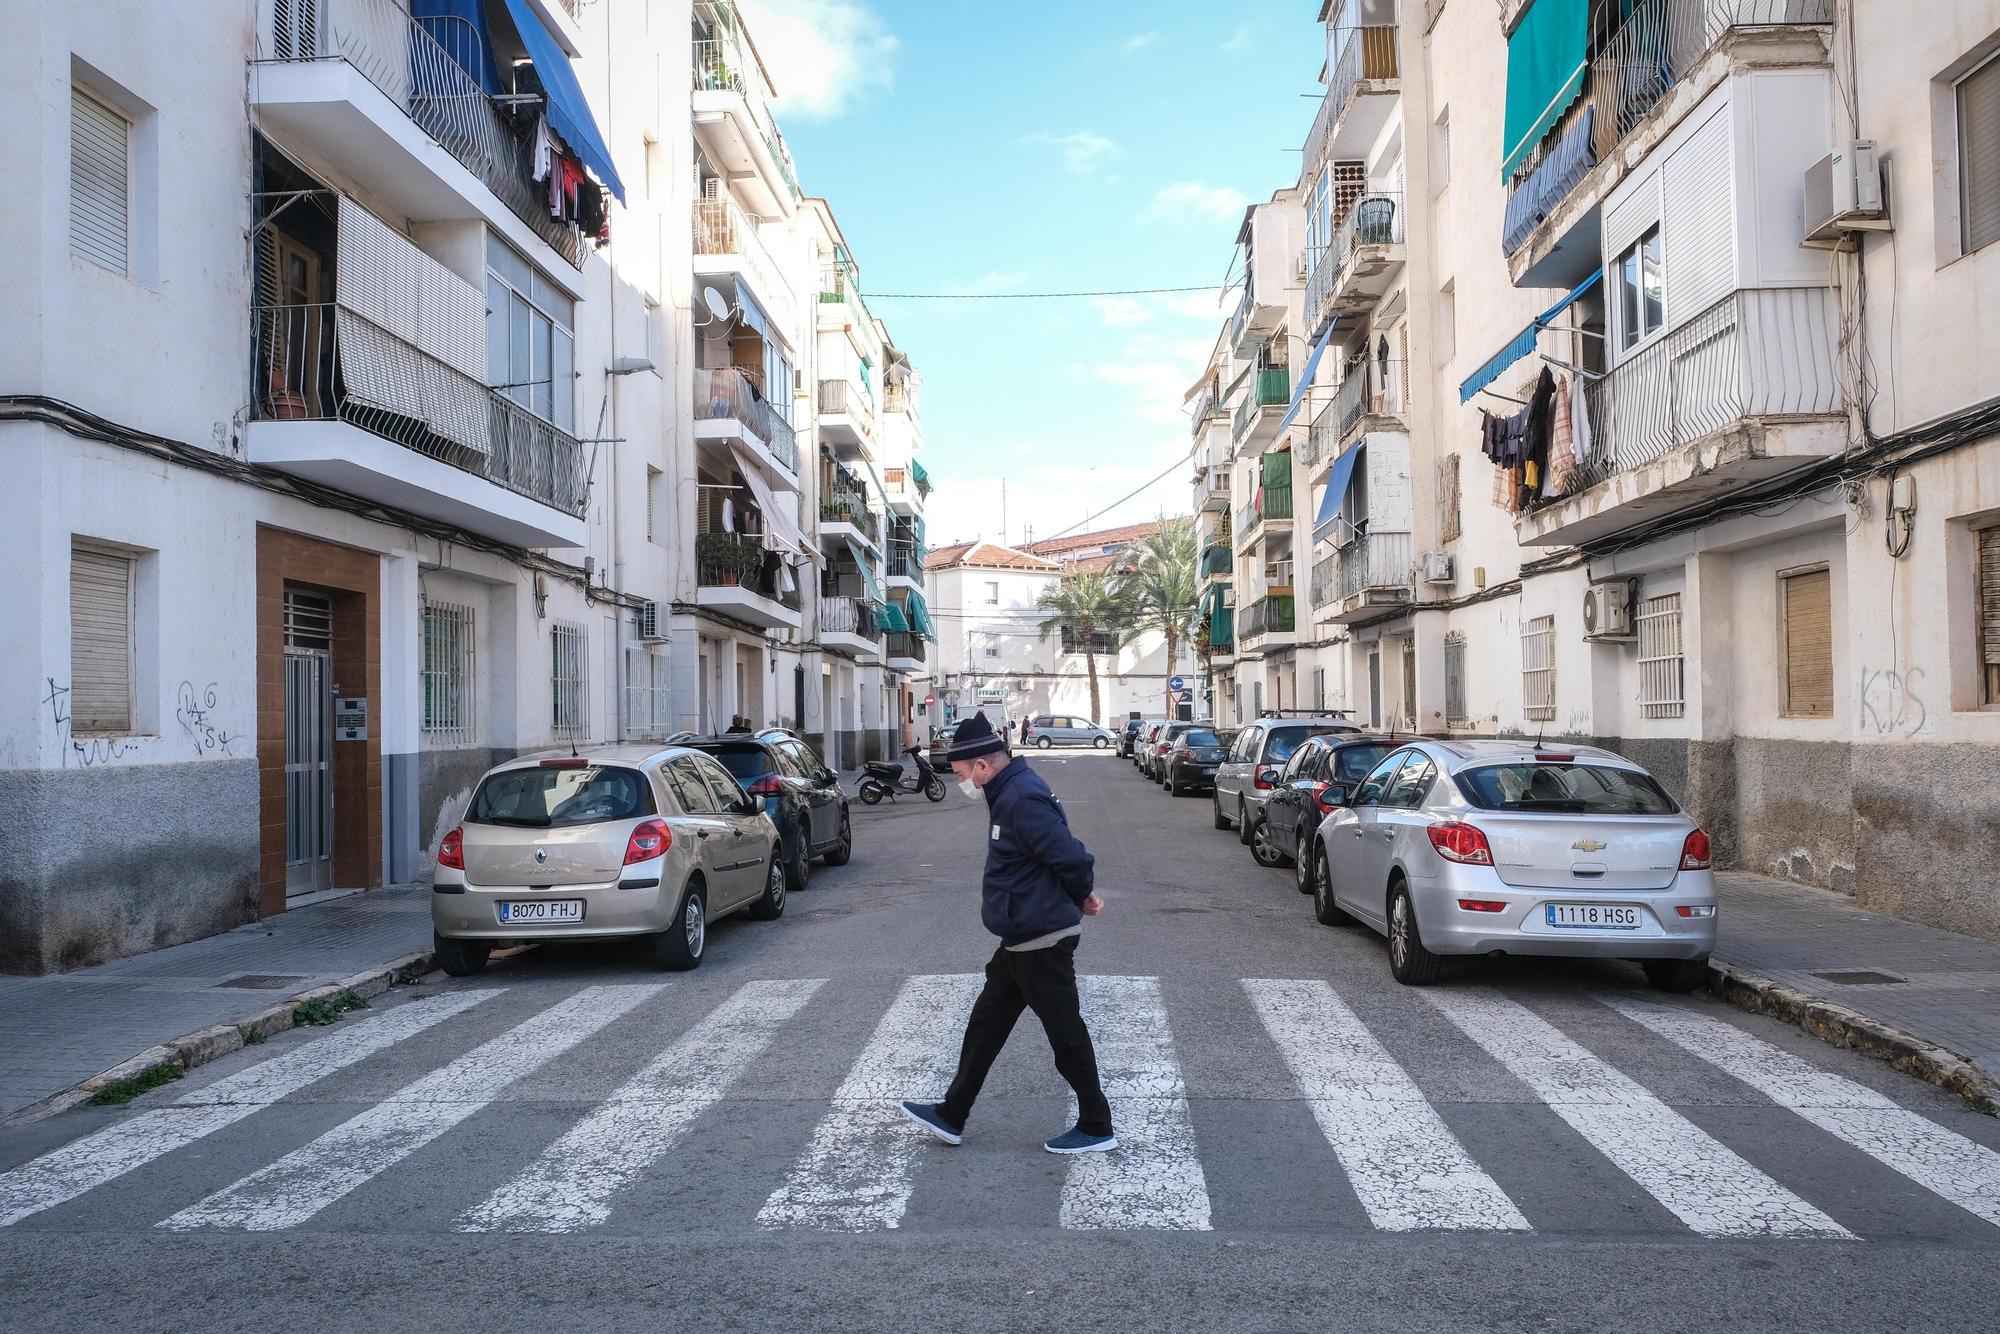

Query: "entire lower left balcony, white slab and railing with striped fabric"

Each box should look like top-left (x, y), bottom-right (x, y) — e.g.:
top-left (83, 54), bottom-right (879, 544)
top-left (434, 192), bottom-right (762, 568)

top-left (246, 304), bottom-right (588, 548)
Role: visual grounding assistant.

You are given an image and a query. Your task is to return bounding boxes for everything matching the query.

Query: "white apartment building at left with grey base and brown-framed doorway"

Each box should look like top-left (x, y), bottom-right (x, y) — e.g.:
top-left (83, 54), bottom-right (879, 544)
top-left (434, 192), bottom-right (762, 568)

top-left (0, 0), bottom-right (918, 972)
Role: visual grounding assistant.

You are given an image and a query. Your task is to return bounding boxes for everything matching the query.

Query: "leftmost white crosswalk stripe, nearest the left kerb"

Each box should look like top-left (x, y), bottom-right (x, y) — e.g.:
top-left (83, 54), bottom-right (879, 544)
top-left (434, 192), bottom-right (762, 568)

top-left (0, 988), bottom-right (506, 1228)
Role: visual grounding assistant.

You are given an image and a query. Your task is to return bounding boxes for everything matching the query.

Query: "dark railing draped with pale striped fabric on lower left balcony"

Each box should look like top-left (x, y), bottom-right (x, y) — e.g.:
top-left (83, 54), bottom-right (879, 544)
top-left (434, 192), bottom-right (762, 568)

top-left (252, 304), bottom-right (588, 518)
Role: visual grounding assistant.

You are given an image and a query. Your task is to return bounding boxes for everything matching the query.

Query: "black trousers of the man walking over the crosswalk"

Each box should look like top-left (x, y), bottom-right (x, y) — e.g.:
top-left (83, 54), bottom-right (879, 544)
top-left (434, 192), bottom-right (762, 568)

top-left (938, 936), bottom-right (1112, 1134)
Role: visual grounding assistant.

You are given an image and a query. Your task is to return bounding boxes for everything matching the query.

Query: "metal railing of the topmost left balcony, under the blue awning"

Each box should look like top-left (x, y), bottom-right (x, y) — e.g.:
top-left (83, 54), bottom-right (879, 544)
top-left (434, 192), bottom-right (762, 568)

top-left (260, 0), bottom-right (584, 268)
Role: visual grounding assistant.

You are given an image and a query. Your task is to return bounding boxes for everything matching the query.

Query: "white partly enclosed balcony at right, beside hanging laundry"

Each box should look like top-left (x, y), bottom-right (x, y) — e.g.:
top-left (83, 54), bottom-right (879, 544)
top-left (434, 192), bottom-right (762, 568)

top-left (1514, 288), bottom-right (1846, 546)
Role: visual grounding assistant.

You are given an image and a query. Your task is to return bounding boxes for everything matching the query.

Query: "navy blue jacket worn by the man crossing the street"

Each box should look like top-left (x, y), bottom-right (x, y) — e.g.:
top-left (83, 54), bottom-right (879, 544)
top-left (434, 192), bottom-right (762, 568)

top-left (980, 756), bottom-right (1096, 944)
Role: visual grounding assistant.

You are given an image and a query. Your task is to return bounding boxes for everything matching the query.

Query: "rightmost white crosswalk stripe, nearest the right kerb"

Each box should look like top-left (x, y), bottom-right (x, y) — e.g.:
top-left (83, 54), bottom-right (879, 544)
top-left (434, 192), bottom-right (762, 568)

top-left (1606, 1000), bottom-right (2000, 1224)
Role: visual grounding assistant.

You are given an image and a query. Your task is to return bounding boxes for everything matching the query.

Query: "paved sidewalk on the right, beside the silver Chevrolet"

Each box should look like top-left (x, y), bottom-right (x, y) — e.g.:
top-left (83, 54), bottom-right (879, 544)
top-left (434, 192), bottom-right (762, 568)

top-left (1716, 872), bottom-right (2000, 1096)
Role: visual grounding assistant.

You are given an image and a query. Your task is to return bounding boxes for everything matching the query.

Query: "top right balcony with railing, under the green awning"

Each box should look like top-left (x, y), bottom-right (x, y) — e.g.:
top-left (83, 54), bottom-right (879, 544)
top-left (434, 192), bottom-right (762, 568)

top-left (1502, 0), bottom-right (1834, 288)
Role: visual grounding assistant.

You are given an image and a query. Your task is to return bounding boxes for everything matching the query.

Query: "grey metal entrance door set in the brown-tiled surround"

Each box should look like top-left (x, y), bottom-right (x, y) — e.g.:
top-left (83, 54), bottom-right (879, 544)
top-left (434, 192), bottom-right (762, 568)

top-left (284, 588), bottom-right (334, 898)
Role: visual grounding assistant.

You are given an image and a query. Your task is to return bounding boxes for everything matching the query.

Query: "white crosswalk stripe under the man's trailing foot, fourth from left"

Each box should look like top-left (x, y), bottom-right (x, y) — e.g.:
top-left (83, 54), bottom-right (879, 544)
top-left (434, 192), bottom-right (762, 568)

top-left (758, 972), bottom-right (984, 1232)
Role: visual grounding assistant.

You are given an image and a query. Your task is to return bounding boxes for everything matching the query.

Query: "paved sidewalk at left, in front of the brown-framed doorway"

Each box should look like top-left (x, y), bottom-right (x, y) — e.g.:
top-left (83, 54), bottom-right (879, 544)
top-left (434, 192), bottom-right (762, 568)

top-left (0, 884), bottom-right (430, 1118)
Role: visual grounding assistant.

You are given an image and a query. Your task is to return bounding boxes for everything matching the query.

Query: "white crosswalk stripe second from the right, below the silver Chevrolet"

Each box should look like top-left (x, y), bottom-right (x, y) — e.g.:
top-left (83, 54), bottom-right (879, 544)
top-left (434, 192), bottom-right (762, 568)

top-left (1418, 988), bottom-right (1854, 1238)
